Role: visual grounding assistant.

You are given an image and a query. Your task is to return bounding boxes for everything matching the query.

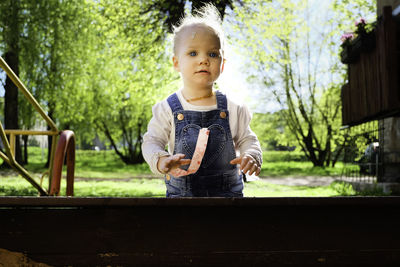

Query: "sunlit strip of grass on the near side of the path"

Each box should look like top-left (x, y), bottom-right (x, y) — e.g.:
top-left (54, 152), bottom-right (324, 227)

top-left (0, 176), bottom-right (356, 197)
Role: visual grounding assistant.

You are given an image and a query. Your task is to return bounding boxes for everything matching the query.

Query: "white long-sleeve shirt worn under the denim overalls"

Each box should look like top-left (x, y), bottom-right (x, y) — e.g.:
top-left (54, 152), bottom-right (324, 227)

top-left (142, 90), bottom-right (262, 174)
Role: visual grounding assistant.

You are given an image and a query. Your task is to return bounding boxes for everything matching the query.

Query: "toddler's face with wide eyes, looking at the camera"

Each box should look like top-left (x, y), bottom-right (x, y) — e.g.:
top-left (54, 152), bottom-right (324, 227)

top-left (172, 25), bottom-right (224, 89)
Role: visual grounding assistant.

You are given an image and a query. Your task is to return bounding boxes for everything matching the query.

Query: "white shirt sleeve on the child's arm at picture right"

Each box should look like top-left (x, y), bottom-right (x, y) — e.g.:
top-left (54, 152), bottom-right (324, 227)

top-left (235, 105), bottom-right (262, 166)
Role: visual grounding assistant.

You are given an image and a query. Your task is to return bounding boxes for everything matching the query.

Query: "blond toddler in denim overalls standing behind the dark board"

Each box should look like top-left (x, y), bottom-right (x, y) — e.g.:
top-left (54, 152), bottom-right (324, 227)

top-left (142, 4), bottom-right (262, 197)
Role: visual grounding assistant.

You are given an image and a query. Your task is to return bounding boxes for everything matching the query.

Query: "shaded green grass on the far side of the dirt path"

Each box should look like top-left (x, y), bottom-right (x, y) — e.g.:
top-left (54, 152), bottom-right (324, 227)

top-left (21, 147), bottom-right (343, 178)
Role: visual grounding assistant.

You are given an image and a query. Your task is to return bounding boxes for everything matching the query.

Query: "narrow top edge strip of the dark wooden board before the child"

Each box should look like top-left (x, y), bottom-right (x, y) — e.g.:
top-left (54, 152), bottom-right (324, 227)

top-left (0, 196), bottom-right (400, 209)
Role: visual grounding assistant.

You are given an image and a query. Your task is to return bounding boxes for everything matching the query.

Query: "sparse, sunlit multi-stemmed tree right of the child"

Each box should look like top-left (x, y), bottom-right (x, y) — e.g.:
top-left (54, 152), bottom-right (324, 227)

top-left (235, 0), bottom-right (376, 166)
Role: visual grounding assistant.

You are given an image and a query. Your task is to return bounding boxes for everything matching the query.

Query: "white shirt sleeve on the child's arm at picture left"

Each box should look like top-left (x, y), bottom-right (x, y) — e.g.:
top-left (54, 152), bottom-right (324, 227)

top-left (142, 100), bottom-right (172, 175)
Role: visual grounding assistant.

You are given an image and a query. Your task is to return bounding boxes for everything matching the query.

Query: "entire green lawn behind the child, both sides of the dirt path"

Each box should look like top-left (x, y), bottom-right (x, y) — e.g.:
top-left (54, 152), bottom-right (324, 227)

top-left (0, 147), bottom-right (376, 197)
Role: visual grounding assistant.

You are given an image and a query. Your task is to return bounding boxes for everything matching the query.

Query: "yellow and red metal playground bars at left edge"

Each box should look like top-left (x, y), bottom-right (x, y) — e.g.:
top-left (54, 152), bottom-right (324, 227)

top-left (0, 57), bottom-right (75, 196)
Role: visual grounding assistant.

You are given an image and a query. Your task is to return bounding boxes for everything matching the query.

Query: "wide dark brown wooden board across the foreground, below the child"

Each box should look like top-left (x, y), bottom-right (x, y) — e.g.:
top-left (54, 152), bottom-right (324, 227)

top-left (0, 197), bottom-right (400, 266)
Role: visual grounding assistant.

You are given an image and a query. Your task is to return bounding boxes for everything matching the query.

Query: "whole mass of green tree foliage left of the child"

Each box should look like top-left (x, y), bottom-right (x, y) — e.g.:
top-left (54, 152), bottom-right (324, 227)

top-left (0, 0), bottom-right (181, 163)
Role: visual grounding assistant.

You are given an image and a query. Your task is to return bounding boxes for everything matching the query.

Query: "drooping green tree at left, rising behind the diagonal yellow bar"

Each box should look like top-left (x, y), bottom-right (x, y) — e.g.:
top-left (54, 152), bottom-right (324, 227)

top-left (17, 1), bottom-right (95, 166)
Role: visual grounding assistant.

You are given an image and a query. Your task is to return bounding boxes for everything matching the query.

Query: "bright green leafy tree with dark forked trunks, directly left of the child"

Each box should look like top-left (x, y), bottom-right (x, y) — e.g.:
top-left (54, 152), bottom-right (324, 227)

top-left (77, 1), bottom-right (176, 164)
